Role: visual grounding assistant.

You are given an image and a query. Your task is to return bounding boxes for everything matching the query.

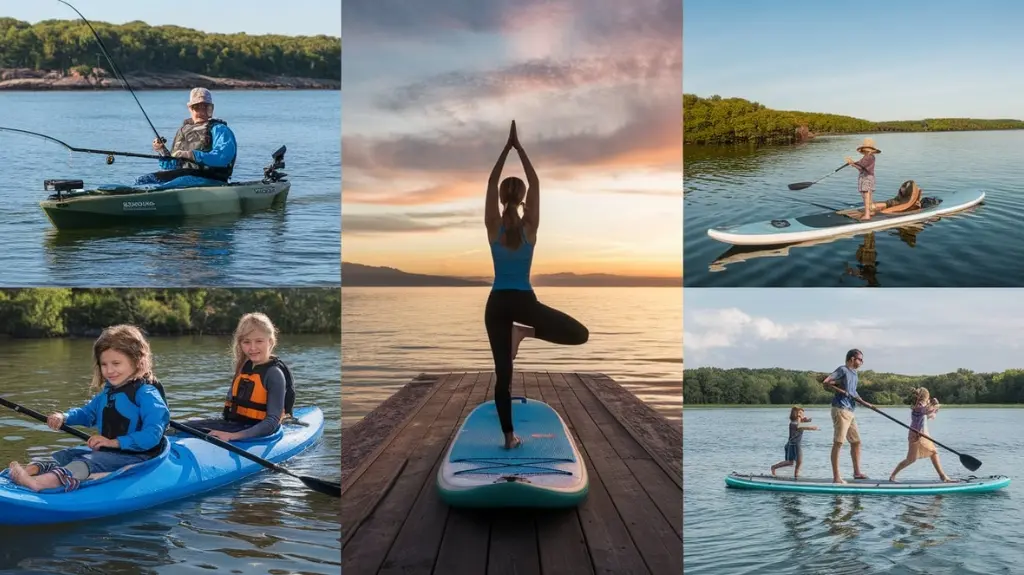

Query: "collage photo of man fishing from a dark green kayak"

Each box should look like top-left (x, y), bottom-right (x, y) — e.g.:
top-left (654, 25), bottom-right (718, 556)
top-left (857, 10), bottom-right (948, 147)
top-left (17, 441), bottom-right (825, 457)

top-left (0, 0), bottom-right (341, 288)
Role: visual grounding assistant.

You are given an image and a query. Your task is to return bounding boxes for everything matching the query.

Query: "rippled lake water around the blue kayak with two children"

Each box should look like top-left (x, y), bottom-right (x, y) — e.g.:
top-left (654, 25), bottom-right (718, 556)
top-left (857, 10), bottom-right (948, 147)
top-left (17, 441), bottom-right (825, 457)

top-left (0, 335), bottom-right (341, 575)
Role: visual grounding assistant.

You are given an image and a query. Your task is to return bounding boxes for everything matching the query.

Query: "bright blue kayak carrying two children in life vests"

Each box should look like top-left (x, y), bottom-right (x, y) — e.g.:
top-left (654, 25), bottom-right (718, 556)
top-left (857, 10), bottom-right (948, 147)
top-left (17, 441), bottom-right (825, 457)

top-left (0, 407), bottom-right (324, 525)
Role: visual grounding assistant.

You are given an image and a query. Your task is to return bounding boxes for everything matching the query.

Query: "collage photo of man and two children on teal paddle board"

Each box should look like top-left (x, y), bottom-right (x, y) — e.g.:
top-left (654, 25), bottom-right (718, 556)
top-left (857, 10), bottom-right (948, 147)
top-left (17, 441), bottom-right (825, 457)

top-left (684, 289), bottom-right (1024, 575)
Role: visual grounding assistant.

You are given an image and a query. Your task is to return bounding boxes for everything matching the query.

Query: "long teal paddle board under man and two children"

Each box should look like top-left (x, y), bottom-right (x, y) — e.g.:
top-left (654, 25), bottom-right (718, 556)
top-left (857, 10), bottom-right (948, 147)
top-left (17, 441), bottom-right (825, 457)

top-left (725, 473), bottom-right (1010, 495)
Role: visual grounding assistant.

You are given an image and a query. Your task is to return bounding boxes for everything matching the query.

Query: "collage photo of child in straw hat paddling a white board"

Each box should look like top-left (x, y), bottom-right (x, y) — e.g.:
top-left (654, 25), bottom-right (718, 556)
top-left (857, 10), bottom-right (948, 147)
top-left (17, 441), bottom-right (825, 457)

top-left (684, 0), bottom-right (1024, 288)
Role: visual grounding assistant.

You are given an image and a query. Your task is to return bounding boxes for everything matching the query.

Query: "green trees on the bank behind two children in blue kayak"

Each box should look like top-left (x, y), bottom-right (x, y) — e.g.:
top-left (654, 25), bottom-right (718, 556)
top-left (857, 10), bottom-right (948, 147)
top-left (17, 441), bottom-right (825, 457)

top-left (0, 288), bottom-right (341, 339)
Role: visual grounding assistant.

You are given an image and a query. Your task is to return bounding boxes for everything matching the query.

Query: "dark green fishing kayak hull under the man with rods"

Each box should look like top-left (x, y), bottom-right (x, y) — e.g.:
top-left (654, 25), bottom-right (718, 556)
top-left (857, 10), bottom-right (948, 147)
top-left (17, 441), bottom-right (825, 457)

top-left (39, 181), bottom-right (292, 229)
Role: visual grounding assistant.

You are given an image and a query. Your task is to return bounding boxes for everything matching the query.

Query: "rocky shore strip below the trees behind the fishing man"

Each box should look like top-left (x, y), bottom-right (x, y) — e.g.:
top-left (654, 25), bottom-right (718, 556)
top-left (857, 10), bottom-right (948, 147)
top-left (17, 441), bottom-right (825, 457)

top-left (0, 68), bottom-right (341, 91)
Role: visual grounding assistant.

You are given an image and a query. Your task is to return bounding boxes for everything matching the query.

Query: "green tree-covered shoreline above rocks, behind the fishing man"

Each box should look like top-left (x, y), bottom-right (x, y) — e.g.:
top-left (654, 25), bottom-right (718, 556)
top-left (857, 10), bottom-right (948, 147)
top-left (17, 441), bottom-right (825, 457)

top-left (0, 17), bottom-right (341, 90)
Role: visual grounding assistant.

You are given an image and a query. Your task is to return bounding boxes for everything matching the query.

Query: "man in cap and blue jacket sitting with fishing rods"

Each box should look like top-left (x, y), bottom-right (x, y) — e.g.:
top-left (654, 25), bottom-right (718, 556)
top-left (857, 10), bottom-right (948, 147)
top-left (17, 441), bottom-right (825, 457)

top-left (135, 88), bottom-right (238, 188)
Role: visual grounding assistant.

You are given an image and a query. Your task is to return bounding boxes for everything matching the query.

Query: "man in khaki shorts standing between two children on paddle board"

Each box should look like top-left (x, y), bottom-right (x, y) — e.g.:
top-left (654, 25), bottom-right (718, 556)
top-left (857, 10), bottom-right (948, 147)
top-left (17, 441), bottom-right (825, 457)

top-left (821, 349), bottom-right (871, 483)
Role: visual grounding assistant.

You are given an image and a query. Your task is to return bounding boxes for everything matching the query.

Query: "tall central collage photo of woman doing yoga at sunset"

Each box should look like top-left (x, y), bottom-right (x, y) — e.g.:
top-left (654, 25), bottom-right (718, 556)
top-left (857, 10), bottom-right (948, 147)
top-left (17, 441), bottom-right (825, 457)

top-left (341, 0), bottom-right (683, 575)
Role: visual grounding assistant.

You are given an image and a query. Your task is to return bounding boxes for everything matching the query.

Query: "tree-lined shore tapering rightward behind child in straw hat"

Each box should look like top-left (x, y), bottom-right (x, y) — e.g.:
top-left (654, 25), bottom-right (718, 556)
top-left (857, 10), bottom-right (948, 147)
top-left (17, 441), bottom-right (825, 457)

top-left (683, 94), bottom-right (1024, 145)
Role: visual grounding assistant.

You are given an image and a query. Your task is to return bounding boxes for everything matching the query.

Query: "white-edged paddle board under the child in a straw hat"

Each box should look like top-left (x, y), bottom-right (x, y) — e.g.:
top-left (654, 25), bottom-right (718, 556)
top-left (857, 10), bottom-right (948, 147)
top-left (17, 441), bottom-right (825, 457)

top-left (708, 191), bottom-right (985, 246)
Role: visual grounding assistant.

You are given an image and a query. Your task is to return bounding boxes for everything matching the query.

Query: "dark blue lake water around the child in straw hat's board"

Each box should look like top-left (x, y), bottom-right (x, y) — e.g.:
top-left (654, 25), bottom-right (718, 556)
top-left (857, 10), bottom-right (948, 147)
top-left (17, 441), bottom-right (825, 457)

top-left (684, 131), bottom-right (1024, 288)
